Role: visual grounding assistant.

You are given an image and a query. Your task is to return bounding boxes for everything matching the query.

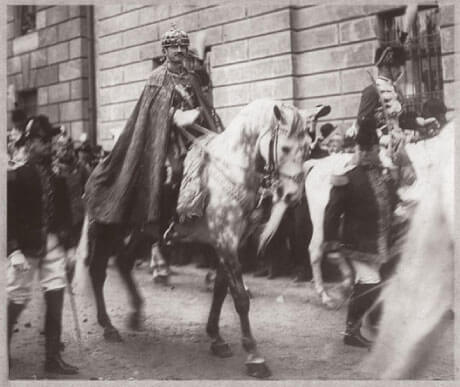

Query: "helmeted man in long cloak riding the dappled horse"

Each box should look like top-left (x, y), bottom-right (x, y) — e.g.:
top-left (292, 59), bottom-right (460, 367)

top-left (85, 28), bottom-right (221, 280)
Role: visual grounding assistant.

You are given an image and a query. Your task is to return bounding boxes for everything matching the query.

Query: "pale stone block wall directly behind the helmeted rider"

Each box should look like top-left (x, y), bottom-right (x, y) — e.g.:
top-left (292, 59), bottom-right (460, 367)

top-left (95, 2), bottom-right (293, 148)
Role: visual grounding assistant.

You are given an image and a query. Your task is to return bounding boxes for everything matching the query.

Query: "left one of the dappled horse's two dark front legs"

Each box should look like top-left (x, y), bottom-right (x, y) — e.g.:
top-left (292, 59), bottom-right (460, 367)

top-left (206, 264), bottom-right (233, 357)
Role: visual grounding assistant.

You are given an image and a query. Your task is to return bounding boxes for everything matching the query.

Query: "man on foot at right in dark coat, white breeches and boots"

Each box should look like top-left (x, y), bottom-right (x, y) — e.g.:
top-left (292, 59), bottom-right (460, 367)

top-left (323, 113), bottom-right (397, 347)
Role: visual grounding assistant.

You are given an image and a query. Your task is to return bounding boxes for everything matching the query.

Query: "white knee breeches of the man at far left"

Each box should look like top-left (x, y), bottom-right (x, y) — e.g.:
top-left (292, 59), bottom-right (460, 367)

top-left (6, 234), bottom-right (66, 304)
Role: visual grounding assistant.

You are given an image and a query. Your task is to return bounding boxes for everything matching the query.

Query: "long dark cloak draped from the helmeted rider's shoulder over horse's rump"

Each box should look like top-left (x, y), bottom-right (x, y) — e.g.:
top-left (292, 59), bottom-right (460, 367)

top-left (85, 65), bottom-right (174, 225)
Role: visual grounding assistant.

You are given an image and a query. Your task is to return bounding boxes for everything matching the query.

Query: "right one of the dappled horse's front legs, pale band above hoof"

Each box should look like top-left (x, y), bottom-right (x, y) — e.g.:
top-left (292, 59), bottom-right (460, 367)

top-left (221, 251), bottom-right (271, 378)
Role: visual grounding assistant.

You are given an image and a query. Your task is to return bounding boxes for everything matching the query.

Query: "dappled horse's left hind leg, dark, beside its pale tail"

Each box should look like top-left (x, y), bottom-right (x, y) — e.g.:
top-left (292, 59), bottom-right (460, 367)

top-left (88, 222), bottom-right (121, 342)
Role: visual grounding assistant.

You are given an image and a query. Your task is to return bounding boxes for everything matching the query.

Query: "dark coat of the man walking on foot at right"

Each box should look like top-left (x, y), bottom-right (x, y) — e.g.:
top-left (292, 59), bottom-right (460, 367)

top-left (323, 163), bottom-right (397, 263)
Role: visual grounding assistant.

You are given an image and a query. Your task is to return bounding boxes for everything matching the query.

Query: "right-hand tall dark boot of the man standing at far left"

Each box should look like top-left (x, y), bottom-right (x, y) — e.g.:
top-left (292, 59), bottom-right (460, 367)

top-left (45, 289), bottom-right (78, 375)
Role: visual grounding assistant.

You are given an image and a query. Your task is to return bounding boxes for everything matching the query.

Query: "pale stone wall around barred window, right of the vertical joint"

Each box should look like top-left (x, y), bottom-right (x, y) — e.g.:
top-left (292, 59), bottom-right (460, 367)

top-left (292, 4), bottom-right (455, 133)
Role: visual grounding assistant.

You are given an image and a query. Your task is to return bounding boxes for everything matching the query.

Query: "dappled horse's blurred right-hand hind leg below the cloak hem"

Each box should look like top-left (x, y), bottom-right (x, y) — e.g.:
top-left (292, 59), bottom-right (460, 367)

top-left (116, 232), bottom-right (144, 330)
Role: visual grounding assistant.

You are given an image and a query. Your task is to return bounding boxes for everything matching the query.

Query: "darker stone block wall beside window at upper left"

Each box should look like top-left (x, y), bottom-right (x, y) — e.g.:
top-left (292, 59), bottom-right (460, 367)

top-left (7, 6), bottom-right (89, 138)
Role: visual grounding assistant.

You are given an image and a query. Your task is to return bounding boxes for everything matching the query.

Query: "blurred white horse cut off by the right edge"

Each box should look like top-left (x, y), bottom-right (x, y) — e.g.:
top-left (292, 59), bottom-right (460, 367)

top-left (369, 122), bottom-right (455, 379)
